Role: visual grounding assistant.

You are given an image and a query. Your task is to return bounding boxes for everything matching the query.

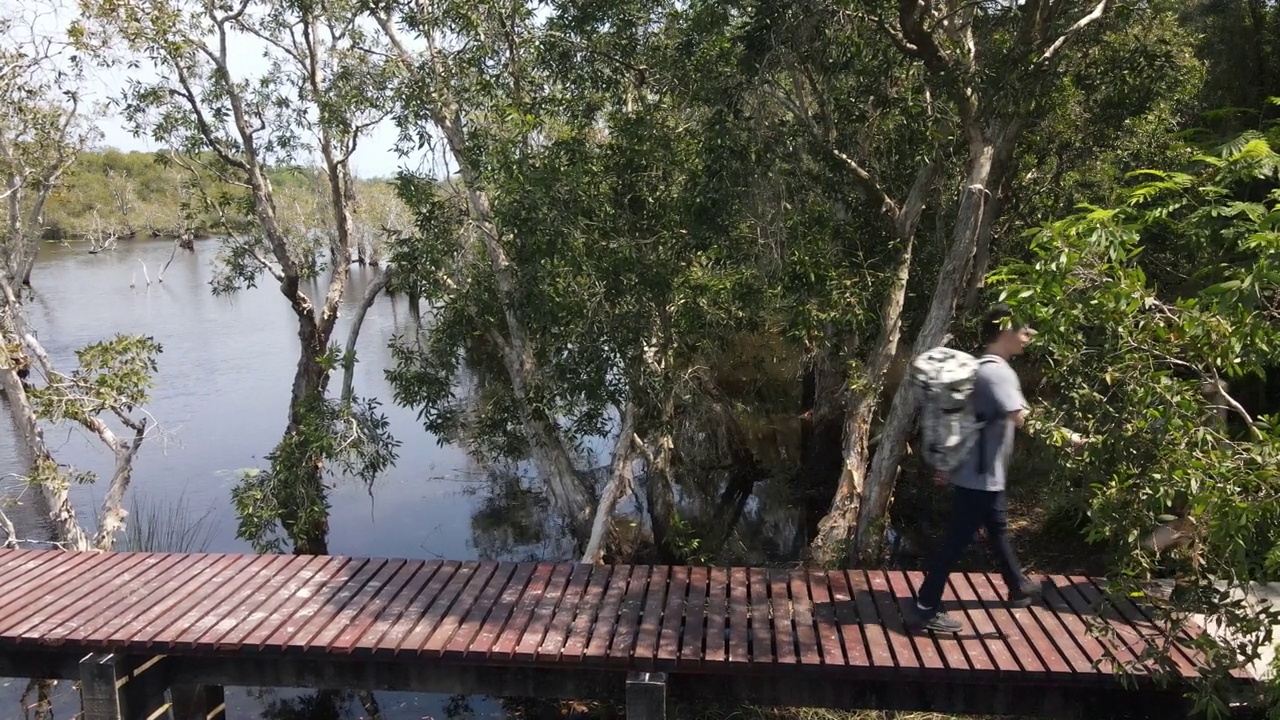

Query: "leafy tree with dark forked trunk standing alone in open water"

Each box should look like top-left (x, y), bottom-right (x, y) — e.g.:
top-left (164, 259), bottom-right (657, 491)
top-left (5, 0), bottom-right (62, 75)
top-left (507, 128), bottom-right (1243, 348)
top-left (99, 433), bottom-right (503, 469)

top-left (82, 0), bottom-right (394, 552)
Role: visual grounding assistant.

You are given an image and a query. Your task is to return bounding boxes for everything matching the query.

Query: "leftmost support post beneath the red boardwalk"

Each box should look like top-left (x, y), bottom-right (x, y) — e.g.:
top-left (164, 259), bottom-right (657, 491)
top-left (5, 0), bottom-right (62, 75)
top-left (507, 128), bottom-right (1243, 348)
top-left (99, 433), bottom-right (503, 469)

top-left (79, 653), bottom-right (173, 720)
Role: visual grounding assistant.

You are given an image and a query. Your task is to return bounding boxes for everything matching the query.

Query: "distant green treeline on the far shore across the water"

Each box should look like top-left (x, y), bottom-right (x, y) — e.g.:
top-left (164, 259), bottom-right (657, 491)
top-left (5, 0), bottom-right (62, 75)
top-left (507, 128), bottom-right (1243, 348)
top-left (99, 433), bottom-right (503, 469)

top-left (45, 149), bottom-right (398, 241)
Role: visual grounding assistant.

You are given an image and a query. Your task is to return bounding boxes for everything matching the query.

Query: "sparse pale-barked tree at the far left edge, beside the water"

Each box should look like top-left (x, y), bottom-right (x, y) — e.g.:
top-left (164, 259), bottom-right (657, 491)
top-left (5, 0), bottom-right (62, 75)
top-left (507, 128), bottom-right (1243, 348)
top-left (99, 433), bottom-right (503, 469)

top-left (0, 8), bottom-right (160, 550)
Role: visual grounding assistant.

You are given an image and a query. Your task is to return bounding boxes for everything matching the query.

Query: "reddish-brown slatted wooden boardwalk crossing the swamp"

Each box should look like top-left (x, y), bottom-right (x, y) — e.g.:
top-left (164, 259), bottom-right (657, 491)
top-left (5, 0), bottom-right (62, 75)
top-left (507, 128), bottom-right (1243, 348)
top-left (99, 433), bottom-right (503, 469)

top-left (0, 550), bottom-right (1249, 712)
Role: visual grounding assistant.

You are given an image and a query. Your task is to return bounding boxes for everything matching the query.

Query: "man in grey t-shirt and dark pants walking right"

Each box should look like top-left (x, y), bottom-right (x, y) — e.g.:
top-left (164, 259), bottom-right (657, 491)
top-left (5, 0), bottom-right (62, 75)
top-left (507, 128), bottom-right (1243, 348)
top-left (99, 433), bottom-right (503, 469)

top-left (915, 304), bottom-right (1041, 633)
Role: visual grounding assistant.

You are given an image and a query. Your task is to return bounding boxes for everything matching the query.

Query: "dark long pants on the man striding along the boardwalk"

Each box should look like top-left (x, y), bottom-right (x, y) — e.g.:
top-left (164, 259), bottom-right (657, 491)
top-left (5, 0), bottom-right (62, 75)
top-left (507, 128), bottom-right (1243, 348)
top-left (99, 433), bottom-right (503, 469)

top-left (916, 488), bottom-right (1023, 610)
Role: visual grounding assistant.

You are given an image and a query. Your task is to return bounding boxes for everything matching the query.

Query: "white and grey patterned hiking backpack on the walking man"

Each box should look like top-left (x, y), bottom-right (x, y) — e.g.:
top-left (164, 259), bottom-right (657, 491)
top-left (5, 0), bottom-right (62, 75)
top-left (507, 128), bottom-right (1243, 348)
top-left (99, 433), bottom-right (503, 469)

top-left (911, 347), bottom-right (992, 473)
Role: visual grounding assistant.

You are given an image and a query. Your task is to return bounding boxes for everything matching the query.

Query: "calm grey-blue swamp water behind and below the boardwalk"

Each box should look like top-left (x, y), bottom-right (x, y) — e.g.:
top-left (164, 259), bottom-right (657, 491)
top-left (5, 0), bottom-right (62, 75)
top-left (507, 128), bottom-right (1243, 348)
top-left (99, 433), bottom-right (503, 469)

top-left (0, 240), bottom-right (557, 720)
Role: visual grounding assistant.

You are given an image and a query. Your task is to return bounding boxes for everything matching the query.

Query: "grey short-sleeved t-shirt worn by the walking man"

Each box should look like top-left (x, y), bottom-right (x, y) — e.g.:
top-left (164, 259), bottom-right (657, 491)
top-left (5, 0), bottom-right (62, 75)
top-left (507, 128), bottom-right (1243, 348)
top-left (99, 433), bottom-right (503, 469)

top-left (951, 355), bottom-right (1027, 491)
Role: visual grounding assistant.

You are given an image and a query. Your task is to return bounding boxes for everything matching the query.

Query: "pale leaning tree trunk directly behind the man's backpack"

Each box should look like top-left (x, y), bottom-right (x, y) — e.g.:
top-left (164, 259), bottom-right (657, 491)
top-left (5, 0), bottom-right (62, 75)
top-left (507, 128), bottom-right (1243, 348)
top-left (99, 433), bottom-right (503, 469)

top-left (852, 128), bottom-right (1021, 556)
